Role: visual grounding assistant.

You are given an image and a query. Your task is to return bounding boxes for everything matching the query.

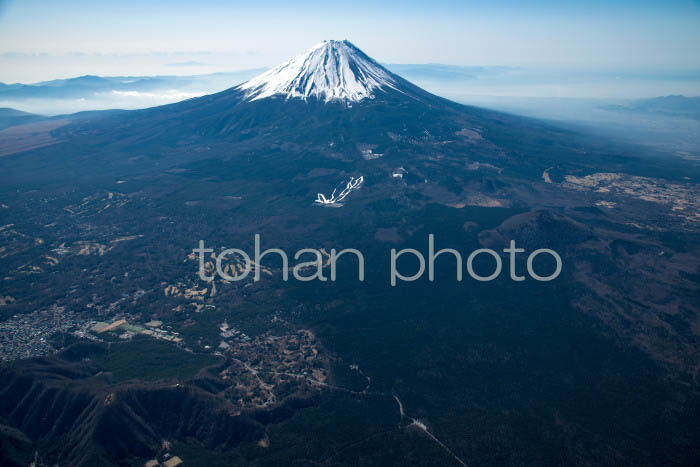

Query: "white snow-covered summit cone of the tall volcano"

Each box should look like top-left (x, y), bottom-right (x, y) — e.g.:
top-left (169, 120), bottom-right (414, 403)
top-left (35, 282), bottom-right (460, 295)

top-left (237, 41), bottom-right (398, 102)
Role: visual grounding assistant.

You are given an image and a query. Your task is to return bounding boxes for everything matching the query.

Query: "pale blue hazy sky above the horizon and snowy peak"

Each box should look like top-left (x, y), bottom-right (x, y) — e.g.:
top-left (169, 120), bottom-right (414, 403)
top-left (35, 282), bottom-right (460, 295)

top-left (0, 0), bottom-right (700, 82)
